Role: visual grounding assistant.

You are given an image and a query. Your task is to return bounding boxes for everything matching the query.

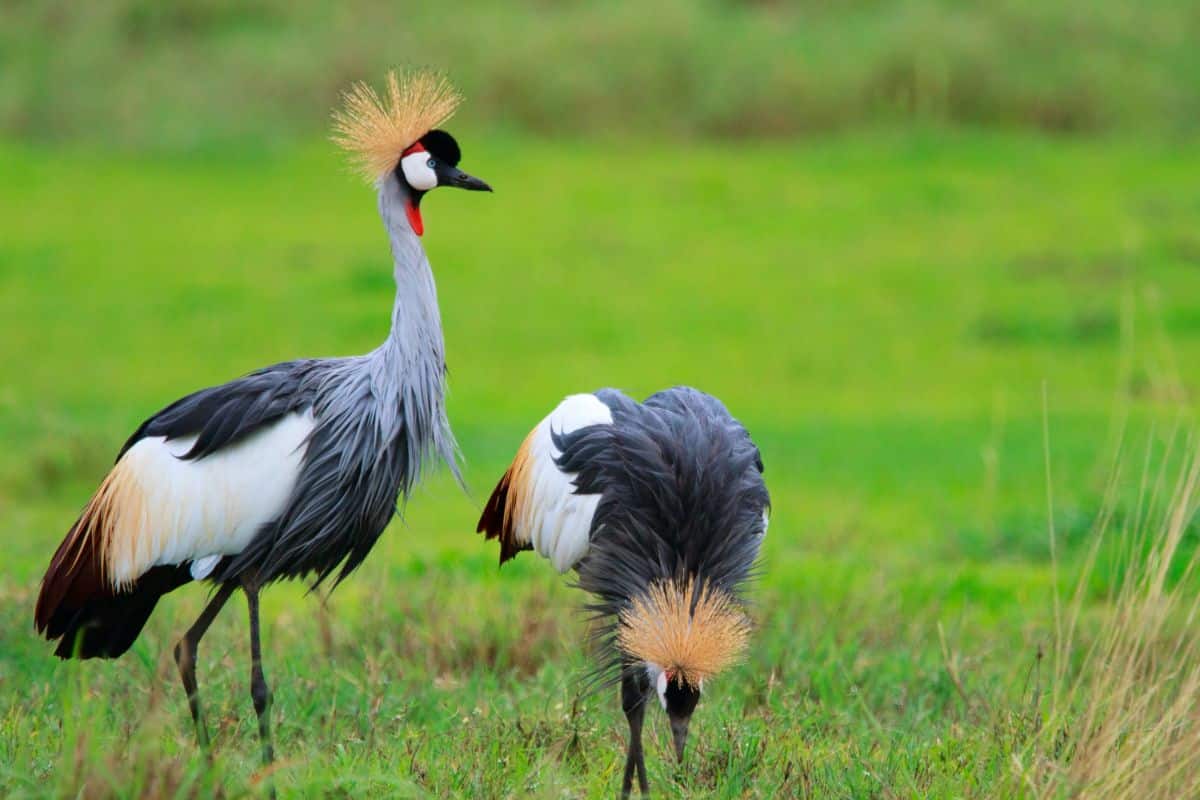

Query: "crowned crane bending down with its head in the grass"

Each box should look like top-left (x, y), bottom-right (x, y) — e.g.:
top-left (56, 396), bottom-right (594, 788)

top-left (478, 386), bottom-right (770, 798)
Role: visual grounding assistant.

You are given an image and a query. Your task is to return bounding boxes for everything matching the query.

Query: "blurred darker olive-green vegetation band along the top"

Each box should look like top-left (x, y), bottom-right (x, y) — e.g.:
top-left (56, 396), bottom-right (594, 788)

top-left (0, 0), bottom-right (1200, 150)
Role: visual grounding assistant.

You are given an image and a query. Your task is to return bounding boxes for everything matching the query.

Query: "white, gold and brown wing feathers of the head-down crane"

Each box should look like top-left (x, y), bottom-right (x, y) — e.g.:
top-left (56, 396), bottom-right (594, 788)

top-left (478, 395), bottom-right (612, 572)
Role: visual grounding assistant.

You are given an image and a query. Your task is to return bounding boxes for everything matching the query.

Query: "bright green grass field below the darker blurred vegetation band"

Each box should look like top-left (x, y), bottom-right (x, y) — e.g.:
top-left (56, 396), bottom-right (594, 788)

top-left (0, 130), bottom-right (1200, 798)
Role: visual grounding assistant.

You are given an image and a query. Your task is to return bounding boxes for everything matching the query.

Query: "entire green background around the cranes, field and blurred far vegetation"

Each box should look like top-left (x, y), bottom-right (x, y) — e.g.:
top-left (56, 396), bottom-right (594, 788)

top-left (0, 0), bottom-right (1200, 798)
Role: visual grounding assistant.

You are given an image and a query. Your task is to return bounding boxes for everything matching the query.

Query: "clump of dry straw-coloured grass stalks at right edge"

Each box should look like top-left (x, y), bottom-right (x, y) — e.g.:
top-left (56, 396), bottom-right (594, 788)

top-left (1014, 441), bottom-right (1200, 800)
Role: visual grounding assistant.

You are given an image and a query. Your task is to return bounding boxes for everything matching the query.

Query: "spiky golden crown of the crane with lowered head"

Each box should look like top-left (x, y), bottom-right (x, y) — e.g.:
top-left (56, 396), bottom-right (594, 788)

top-left (617, 578), bottom-right (751, 687)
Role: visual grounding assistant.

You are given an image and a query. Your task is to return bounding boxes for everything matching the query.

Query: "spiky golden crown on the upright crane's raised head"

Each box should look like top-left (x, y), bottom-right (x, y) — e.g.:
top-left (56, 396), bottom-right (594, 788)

top-left (334, 70), bottom-right (462, 182)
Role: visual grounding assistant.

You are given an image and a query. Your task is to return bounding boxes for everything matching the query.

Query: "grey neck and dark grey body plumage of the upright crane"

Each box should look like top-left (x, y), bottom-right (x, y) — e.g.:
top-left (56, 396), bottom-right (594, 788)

top-left (122, 174), bottom-right (453, 585)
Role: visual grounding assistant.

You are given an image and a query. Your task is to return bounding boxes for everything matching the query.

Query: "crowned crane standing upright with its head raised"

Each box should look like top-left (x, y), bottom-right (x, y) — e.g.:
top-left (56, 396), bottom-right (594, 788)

top-left (35, 72), bottom-right (491, 763)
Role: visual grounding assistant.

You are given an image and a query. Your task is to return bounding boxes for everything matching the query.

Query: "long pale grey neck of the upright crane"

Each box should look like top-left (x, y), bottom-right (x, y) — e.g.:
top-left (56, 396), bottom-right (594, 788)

top-left (368, 173), bottom-right (462, 482)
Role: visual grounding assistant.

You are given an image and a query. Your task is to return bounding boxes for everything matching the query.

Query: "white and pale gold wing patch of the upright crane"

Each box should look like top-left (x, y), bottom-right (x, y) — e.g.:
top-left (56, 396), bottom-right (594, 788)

top-left (63, 411), bottom-right (313, 589)
